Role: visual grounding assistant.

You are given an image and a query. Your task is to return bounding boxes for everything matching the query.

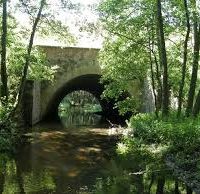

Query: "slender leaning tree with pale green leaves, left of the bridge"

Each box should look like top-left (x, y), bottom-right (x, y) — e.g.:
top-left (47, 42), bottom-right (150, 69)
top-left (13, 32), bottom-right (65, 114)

top-left (2, 0), bottom-right (76, 123)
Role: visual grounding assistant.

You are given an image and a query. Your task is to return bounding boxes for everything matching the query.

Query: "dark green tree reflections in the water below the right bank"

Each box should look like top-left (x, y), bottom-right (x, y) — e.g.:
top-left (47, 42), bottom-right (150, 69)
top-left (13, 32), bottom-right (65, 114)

top-left (92, 161), bottom-right (189, 194)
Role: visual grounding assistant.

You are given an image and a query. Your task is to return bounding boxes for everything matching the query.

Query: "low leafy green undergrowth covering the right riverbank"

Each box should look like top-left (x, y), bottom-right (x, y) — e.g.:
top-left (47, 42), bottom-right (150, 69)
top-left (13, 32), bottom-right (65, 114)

top-left (126, 113), bottom-right (200, 192)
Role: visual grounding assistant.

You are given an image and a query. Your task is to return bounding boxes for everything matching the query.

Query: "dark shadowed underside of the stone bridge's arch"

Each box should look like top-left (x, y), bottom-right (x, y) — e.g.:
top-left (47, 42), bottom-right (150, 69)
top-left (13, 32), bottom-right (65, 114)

top-left (44, 74), bottom-right (128, 124)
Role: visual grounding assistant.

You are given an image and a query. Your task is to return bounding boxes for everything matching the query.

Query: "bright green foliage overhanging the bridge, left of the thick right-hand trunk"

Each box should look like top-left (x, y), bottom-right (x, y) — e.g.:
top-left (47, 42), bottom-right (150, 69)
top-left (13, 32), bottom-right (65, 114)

top-left (99, 0), bottom-right (153, 114)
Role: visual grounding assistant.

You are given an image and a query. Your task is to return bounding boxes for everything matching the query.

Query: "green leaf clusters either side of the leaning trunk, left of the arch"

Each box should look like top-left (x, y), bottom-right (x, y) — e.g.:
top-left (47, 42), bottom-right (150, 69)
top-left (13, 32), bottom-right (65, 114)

top-left (7, 39), bottom-right (55, 95)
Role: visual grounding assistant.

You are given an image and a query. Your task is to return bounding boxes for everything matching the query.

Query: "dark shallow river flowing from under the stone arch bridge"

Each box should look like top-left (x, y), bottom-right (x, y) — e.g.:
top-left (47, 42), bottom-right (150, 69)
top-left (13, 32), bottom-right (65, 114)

top-left (0, 111), bottom-right (193, 194)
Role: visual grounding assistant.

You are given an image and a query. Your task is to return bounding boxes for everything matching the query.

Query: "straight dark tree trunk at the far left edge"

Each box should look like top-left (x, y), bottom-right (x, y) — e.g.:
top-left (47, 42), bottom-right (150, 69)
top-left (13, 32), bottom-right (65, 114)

top-left (1, 0), bottom-right (8, 105)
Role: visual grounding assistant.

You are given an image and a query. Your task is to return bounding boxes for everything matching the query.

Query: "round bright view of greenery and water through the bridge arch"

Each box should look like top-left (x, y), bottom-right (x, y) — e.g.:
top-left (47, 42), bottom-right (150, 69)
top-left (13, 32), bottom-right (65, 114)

top-left (59, 90), bottom-right (102, 126)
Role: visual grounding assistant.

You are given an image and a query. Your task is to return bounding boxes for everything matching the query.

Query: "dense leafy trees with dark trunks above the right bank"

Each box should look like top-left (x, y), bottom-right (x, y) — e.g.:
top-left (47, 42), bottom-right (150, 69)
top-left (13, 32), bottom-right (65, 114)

top-left (100, 0), bottom-right (199, 115)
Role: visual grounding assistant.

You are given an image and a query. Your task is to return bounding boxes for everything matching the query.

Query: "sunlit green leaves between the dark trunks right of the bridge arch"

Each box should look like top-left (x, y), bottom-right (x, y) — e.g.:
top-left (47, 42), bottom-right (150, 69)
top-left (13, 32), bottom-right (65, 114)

top-left (99, 0), bottom-right (199, 116)
